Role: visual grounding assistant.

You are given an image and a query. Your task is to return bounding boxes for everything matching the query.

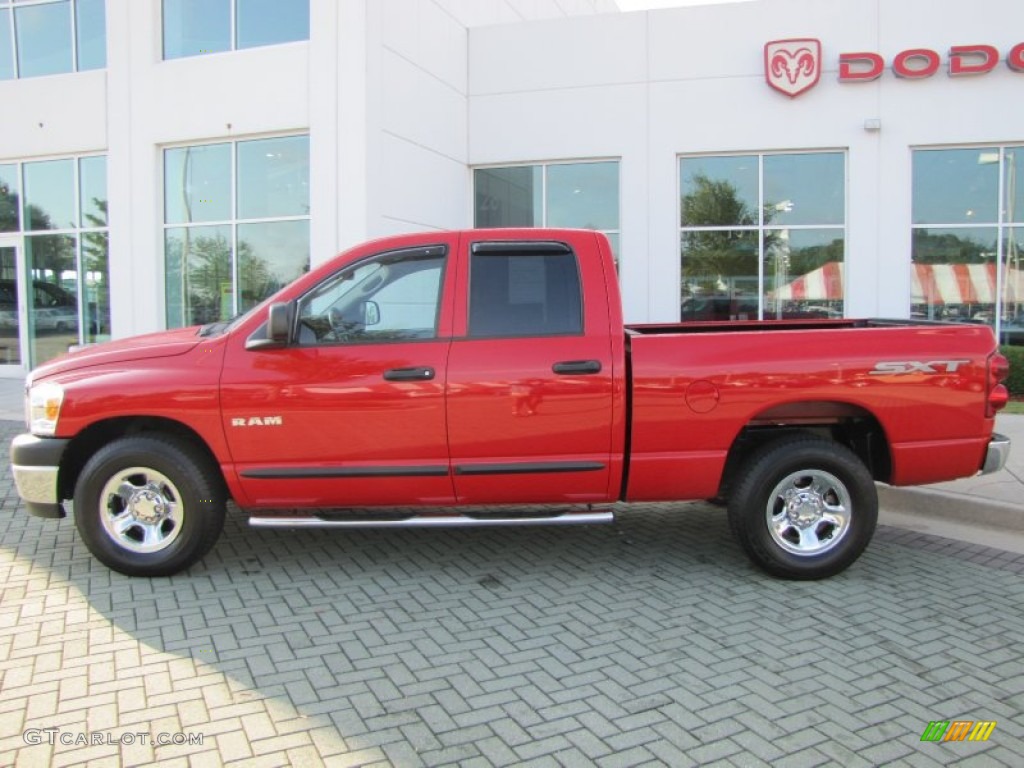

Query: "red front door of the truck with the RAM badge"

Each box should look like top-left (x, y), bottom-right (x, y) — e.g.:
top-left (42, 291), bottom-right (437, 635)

top-left (222, 236), bottom-right (457, 507)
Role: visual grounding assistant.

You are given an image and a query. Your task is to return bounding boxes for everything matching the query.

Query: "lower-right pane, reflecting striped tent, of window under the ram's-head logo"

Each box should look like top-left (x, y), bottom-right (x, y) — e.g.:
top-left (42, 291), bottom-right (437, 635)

top-left (764, 229), bottom-right (846, 319)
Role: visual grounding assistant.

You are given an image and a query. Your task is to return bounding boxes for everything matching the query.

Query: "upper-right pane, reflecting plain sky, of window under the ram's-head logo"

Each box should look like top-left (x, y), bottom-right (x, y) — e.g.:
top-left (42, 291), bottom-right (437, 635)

top-left (764, 153), bottom-right (846, 225)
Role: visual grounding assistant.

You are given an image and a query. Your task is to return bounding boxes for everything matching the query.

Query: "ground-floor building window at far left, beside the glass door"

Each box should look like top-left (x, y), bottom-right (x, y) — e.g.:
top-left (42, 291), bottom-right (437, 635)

top-left (0, 156), bottom-right (111, 367)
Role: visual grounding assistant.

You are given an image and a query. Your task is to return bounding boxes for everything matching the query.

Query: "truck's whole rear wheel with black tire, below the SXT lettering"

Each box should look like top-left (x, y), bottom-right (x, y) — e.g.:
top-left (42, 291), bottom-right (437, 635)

top-left (728, 435), bottom-right (879, 580)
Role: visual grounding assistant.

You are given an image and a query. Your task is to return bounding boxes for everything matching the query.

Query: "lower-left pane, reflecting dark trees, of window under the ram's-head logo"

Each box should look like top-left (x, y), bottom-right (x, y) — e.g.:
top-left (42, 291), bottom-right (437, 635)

top-left (680, 229), bottom-right (758, 321)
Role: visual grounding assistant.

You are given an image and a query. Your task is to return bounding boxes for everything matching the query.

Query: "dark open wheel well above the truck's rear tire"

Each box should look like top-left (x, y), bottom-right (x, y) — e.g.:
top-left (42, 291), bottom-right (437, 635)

top-left (719, 402), bottom-right (892, 498)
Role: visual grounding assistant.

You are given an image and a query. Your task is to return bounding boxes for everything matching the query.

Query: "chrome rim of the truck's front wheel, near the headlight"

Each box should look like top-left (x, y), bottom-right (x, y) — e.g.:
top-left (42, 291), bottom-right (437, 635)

top-left (99, 467), bottom-right (184, 554)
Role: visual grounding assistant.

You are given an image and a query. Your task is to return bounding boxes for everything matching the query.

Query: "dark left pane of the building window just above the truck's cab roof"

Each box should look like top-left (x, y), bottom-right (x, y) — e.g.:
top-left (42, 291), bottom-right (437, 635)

top-left (473, 166), bottom-right (544, 228)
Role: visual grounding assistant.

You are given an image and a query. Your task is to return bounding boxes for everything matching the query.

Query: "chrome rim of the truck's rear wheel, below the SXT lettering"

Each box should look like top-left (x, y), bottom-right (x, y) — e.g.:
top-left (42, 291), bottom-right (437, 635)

top-left (765, 469), bottom-right (853, 557)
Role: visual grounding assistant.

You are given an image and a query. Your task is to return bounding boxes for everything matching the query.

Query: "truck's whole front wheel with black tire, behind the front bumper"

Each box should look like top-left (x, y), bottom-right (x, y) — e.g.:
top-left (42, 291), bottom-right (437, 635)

top-left (75, 435), bottom-right (226, 577)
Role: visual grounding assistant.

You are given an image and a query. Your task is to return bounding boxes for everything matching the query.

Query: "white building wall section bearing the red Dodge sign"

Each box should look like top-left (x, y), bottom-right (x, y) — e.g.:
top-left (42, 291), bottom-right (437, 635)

top-left (469, 0), bottom-right (1024, 322)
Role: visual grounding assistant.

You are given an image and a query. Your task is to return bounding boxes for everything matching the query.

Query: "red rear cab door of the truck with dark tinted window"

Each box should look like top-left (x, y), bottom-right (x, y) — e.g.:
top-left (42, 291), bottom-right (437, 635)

top-left (447, 237), bottom-right (617, 504)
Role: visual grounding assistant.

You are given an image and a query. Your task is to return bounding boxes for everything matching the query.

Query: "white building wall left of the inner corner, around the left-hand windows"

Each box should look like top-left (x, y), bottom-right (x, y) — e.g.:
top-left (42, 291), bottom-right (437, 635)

top-left (0, 0), bottom-right (617, 354)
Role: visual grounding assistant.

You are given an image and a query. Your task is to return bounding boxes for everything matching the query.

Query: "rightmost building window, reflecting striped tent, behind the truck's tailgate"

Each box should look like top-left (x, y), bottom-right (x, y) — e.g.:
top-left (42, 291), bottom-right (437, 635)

top-left (910, 146), bottom-right (1024, 344)
